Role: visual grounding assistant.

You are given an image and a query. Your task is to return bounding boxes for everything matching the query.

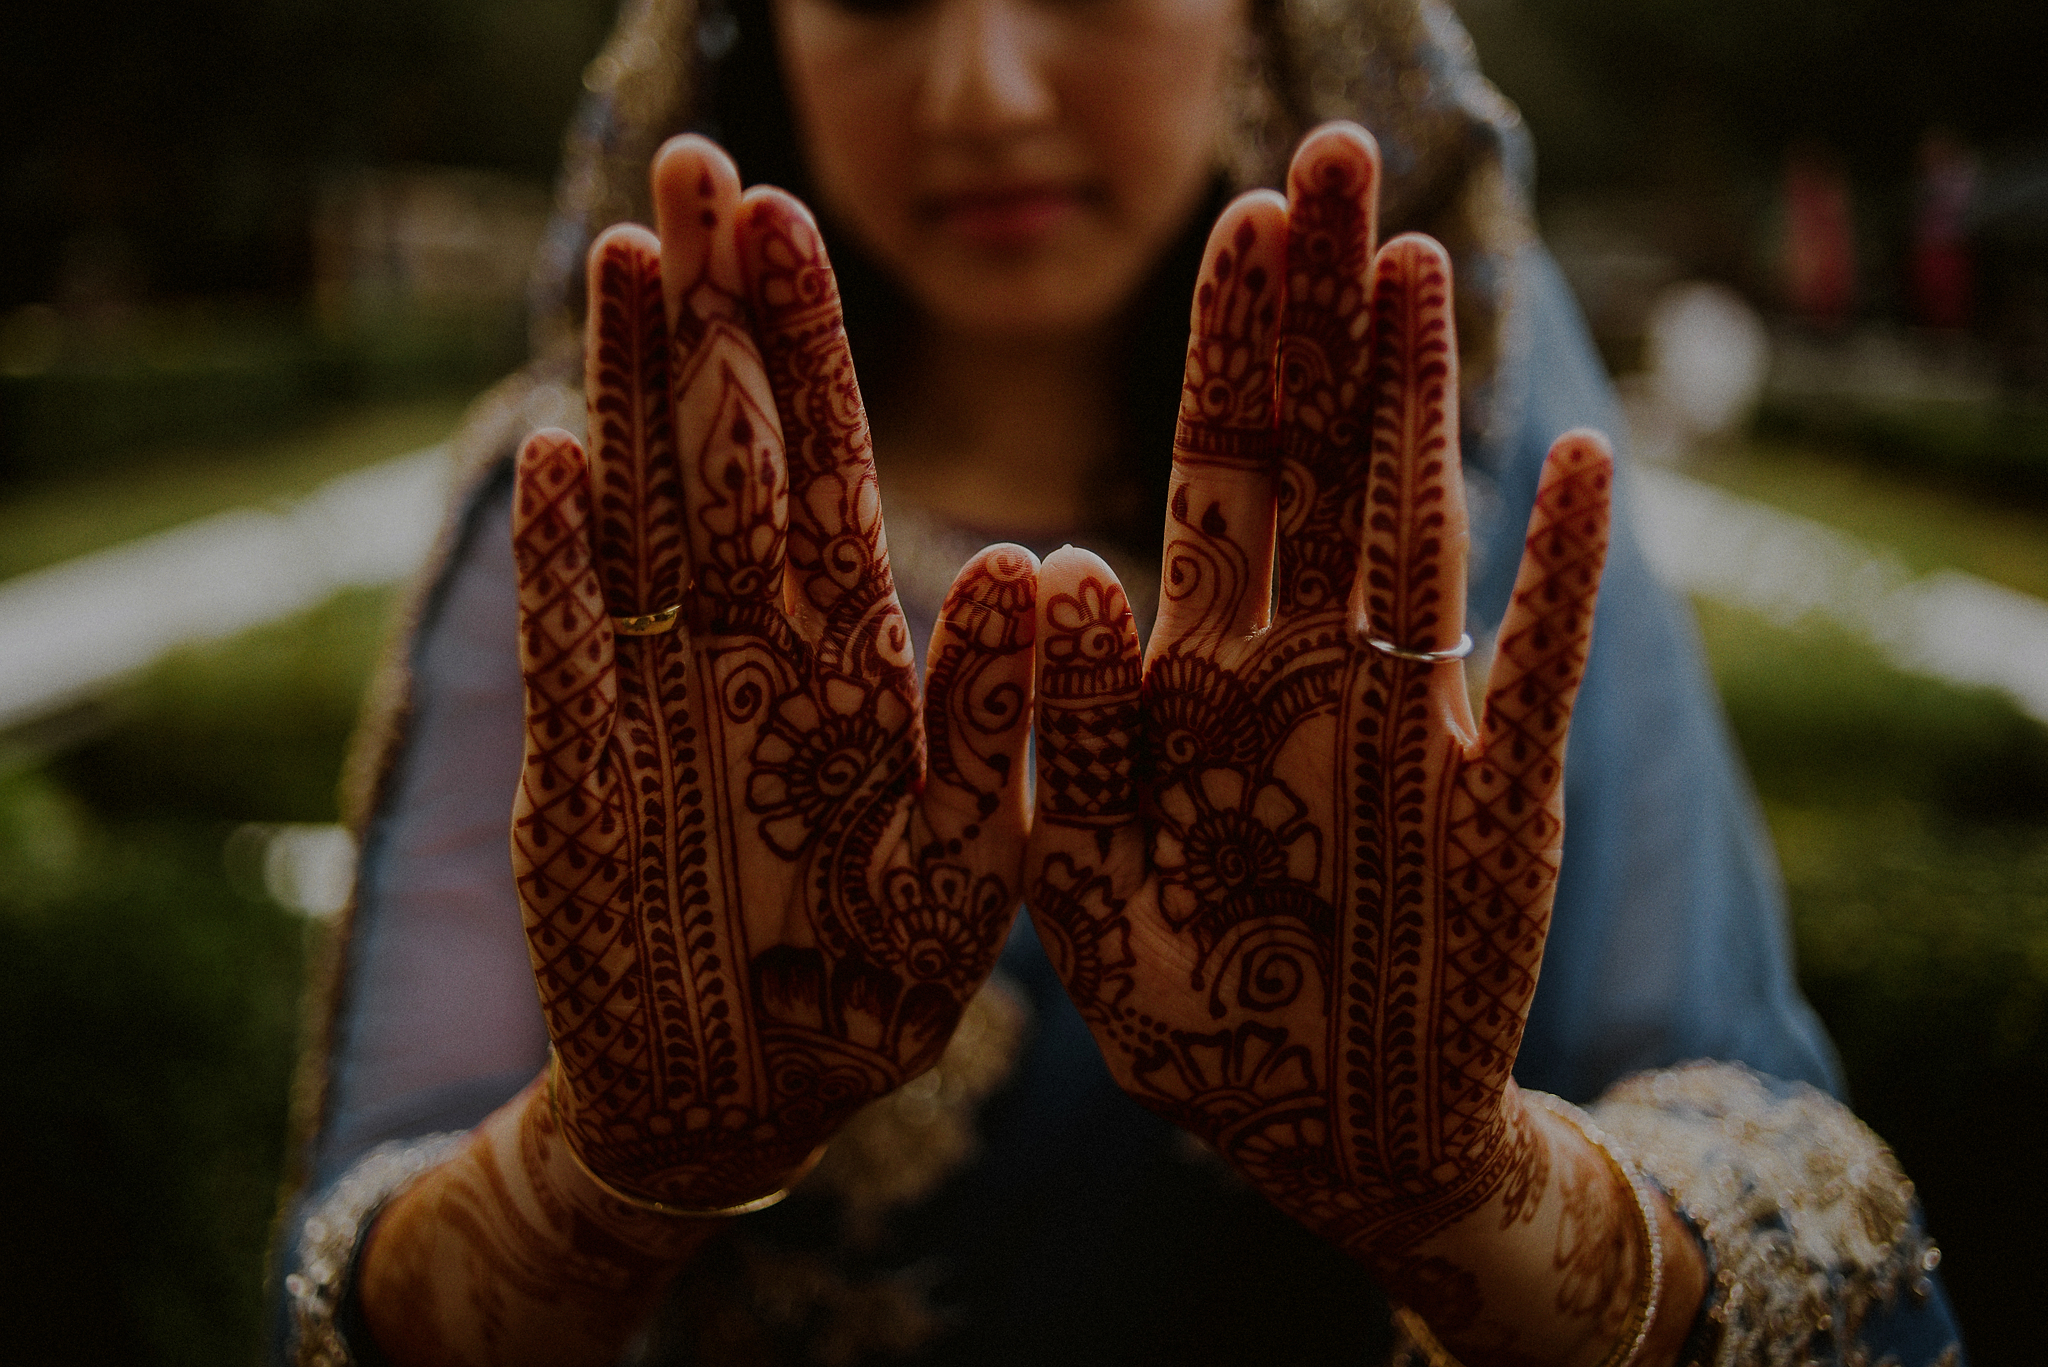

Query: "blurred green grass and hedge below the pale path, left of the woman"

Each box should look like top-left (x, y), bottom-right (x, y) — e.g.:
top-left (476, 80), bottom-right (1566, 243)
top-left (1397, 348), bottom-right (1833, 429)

top-left (0, 592), bottom-right (391, 1367)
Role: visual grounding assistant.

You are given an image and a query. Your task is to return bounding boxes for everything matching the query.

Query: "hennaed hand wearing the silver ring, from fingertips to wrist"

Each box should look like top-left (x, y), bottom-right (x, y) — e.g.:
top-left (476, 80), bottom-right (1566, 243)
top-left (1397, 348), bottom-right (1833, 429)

top-left (1028, 127), bottom-right (1610, 1258)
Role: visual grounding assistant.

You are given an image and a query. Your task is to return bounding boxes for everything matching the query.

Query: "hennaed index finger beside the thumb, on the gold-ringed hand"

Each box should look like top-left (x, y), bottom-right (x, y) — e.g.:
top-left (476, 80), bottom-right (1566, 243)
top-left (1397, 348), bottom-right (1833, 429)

top-left (739, 187), bottom-right (899, 650)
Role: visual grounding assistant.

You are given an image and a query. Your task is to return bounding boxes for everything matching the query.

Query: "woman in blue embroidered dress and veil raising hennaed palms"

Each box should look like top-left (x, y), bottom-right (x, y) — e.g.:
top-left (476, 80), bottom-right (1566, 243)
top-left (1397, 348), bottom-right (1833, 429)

top-left (276, 0), bottom-right (1952, 1363)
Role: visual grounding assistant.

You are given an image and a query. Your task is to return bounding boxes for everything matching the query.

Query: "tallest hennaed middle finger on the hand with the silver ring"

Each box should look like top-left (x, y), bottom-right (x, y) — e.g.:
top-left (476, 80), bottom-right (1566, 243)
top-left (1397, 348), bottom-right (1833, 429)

top-left (1274, 123), bottom-right (1380, 617)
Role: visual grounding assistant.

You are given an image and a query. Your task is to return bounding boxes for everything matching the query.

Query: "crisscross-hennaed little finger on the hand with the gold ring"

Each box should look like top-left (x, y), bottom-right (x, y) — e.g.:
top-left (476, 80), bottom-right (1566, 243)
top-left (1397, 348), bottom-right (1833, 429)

top-left (512, 428), bottom-right (616, 803)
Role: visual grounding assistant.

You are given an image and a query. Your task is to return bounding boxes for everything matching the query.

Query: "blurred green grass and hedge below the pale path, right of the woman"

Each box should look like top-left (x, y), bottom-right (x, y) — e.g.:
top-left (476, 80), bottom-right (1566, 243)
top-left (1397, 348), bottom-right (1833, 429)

top-left (1702, 607), bottom-right (2048, 1363)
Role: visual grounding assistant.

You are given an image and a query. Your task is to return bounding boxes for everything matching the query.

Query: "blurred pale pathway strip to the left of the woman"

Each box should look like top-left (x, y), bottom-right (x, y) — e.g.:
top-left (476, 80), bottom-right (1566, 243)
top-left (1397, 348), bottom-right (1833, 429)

top-left (0, 447), bottom-right (449, 728)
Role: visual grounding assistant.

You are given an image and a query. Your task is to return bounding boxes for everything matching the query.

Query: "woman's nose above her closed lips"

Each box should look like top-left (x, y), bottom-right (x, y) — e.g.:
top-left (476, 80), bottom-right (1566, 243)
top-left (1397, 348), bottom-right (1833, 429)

top-left (920, 0), bottom-right (1059, 139)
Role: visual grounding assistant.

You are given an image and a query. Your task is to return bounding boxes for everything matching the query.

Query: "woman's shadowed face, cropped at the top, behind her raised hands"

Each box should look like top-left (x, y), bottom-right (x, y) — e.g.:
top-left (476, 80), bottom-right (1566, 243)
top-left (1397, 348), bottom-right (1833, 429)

top-left (774, 0), bottom-right (1245, 338)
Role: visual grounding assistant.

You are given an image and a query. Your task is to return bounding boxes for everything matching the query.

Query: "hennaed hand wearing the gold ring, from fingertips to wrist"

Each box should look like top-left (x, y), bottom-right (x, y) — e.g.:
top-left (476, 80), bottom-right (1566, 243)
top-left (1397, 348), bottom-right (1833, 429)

top-left (512, 137), bottom-right (1036, 1205)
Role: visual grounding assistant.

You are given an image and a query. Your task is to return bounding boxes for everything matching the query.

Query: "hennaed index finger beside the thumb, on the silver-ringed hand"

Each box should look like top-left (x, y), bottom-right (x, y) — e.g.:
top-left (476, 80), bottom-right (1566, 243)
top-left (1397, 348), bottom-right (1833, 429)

top-left (1151, 191), bottom-right (1286, 656)
